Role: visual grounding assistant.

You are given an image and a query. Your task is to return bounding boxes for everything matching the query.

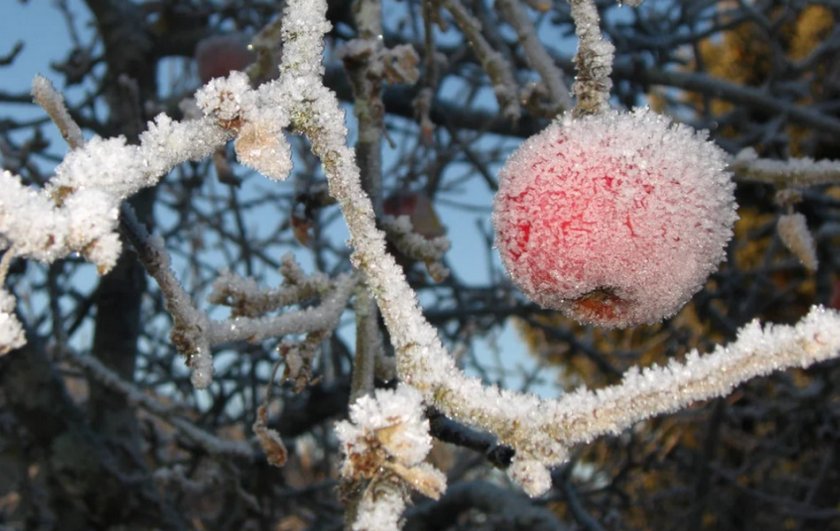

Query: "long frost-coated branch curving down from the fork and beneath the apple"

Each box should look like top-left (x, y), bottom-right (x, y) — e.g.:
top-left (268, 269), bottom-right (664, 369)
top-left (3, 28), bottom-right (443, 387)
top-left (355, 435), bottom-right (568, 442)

top-left (262, 0), bottom-right (840, 512)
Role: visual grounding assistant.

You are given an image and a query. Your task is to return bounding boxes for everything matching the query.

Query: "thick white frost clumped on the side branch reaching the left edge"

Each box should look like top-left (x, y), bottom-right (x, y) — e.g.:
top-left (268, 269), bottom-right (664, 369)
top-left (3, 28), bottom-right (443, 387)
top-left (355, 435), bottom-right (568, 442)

top-left (0, 111), bottom-right (226, 273)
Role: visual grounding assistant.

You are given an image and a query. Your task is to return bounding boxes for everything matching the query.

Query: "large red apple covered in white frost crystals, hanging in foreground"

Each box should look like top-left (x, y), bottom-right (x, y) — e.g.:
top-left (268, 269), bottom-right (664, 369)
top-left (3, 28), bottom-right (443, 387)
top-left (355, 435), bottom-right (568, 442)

top-left (493, 109), bottom-right (737, 327)
